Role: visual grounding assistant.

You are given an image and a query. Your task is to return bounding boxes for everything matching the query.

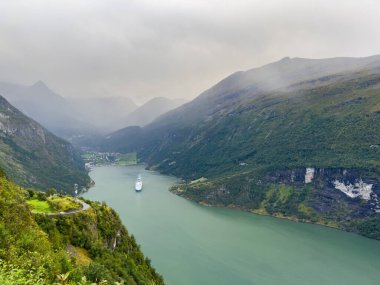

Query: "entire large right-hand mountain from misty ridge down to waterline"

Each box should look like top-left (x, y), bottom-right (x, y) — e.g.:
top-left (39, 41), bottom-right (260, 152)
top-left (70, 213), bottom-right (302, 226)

top-left (99, 56), bottom-right (380, 239)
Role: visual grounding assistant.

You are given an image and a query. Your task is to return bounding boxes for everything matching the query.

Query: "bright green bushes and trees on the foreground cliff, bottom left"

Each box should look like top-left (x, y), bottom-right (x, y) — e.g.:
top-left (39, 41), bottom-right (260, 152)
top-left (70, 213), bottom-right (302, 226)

top-left (0, 171), bottom-right (163, 285)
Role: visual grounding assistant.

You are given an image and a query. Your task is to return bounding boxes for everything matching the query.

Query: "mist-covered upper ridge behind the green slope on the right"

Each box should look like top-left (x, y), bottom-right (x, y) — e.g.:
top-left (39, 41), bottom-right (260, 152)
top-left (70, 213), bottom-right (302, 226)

top-left (130, 55), bottom-right (380, 132)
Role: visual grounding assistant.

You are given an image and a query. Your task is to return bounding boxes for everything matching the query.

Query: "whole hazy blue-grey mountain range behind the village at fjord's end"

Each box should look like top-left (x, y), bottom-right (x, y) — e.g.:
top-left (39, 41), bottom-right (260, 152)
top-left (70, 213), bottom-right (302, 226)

top-left (0, 81), bottom-right (185, 140)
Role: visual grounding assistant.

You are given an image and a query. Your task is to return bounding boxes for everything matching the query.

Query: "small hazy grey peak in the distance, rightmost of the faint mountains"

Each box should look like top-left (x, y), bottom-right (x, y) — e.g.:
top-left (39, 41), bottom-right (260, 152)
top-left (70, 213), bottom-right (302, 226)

top-left (123, 97), bottom-right (186, 127)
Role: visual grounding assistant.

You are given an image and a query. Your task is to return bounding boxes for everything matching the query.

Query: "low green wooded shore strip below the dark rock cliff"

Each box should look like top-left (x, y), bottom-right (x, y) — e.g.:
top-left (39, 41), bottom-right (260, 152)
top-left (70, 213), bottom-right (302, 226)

top-left (170, 174), bottom-right (380, 239)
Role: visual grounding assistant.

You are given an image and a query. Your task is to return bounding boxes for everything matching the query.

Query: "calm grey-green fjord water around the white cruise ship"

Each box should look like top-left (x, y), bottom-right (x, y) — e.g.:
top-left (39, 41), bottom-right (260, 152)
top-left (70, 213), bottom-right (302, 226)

top-left (83, 165), bottom-right (380, 285)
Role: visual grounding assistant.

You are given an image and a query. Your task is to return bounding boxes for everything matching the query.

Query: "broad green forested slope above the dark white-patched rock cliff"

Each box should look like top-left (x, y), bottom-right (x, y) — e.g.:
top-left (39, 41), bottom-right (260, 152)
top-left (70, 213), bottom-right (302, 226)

top-left (151, 72), bottom-right (380, 176)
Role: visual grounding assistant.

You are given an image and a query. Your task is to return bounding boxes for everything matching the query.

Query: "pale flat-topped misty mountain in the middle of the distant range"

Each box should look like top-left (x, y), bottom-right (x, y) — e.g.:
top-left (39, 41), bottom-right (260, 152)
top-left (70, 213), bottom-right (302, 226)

top-left (70, 97), bottom-right (137, 133)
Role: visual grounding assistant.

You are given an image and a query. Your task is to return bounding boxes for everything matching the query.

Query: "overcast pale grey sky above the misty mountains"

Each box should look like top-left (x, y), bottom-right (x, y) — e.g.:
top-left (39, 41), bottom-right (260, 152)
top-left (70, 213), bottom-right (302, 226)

top-left (0, 0), bottom-right (380, 103)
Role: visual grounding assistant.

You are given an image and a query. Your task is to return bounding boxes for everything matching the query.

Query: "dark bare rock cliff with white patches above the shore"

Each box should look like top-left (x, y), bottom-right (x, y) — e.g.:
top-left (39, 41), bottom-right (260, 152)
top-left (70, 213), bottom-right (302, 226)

top-left (265, 168), bottom-right (380, 215)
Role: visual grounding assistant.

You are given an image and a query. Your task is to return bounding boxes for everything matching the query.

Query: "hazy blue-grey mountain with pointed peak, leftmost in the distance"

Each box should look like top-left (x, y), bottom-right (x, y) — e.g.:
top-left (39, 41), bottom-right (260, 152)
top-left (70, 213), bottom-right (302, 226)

top-left (0, 81), bottom-right (96, 138)
